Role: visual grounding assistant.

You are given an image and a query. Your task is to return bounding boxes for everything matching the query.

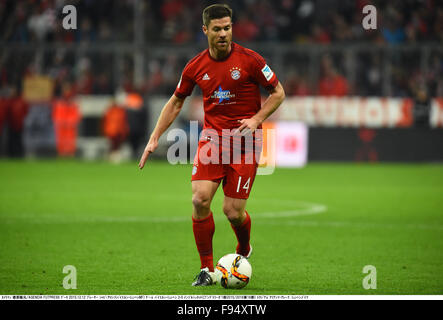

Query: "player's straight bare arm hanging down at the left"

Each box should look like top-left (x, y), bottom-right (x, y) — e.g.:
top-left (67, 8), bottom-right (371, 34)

top-left (138, 95), bottom-right (185, 169)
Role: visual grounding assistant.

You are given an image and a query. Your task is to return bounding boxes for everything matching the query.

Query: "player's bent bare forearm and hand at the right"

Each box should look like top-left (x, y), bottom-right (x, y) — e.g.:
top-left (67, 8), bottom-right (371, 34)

top-left (238, 81), bottom-right (285, 133)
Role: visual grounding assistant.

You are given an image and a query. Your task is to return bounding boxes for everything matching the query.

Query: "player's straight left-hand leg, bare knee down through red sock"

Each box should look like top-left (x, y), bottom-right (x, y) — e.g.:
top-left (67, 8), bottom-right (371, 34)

top-left (192, 180), bottom-right (220, 272)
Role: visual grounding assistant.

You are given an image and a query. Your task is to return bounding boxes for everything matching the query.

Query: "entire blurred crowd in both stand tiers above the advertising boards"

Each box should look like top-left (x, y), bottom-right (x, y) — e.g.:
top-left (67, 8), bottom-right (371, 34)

top-left (0, 0), bottom-right (443, 96)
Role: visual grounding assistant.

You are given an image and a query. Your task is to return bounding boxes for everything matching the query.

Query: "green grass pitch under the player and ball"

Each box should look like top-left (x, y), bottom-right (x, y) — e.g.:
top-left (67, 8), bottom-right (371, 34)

top-left (0, 160), bottom-right (443, 295)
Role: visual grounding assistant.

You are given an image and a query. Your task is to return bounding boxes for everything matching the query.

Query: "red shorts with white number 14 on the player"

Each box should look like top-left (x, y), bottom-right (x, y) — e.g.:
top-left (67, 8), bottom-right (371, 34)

top-left (191, 141), bottom-right (258, 199)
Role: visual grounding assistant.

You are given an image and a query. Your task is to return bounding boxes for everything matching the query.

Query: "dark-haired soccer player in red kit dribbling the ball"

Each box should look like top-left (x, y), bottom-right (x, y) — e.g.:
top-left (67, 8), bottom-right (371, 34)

top-left (139, 4), bottom-right (285, 286)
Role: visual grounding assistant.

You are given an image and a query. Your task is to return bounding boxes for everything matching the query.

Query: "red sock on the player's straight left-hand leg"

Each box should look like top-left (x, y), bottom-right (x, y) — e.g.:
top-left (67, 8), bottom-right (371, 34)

top-left (192, 212), bottom-right (215, 272)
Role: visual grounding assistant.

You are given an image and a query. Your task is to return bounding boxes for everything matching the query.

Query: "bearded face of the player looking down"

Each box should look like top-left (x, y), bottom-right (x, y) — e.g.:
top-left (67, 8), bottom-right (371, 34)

top-left (203, 17), bottom-right (232, 51)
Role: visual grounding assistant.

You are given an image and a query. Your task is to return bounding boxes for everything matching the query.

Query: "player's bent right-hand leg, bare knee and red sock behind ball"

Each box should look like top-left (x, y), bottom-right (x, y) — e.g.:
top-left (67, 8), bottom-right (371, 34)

top-left (223, 196), bottom-right (251, 258)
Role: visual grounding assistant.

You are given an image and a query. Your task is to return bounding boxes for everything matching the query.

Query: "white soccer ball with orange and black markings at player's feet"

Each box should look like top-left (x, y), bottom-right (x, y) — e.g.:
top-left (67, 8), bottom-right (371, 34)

top-left (215, 253), bottom-right (252, 289)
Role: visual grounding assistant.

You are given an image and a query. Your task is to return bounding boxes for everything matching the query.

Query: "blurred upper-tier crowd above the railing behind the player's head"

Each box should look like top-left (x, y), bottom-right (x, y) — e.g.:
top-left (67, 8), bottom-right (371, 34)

top-left (0, 0), bottom-right (443, 44)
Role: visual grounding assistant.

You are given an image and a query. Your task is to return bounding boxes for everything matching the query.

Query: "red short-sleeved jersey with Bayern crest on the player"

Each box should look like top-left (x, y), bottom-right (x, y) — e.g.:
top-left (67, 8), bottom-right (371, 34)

top-left (174, 42), bottom-right (278, 134)
